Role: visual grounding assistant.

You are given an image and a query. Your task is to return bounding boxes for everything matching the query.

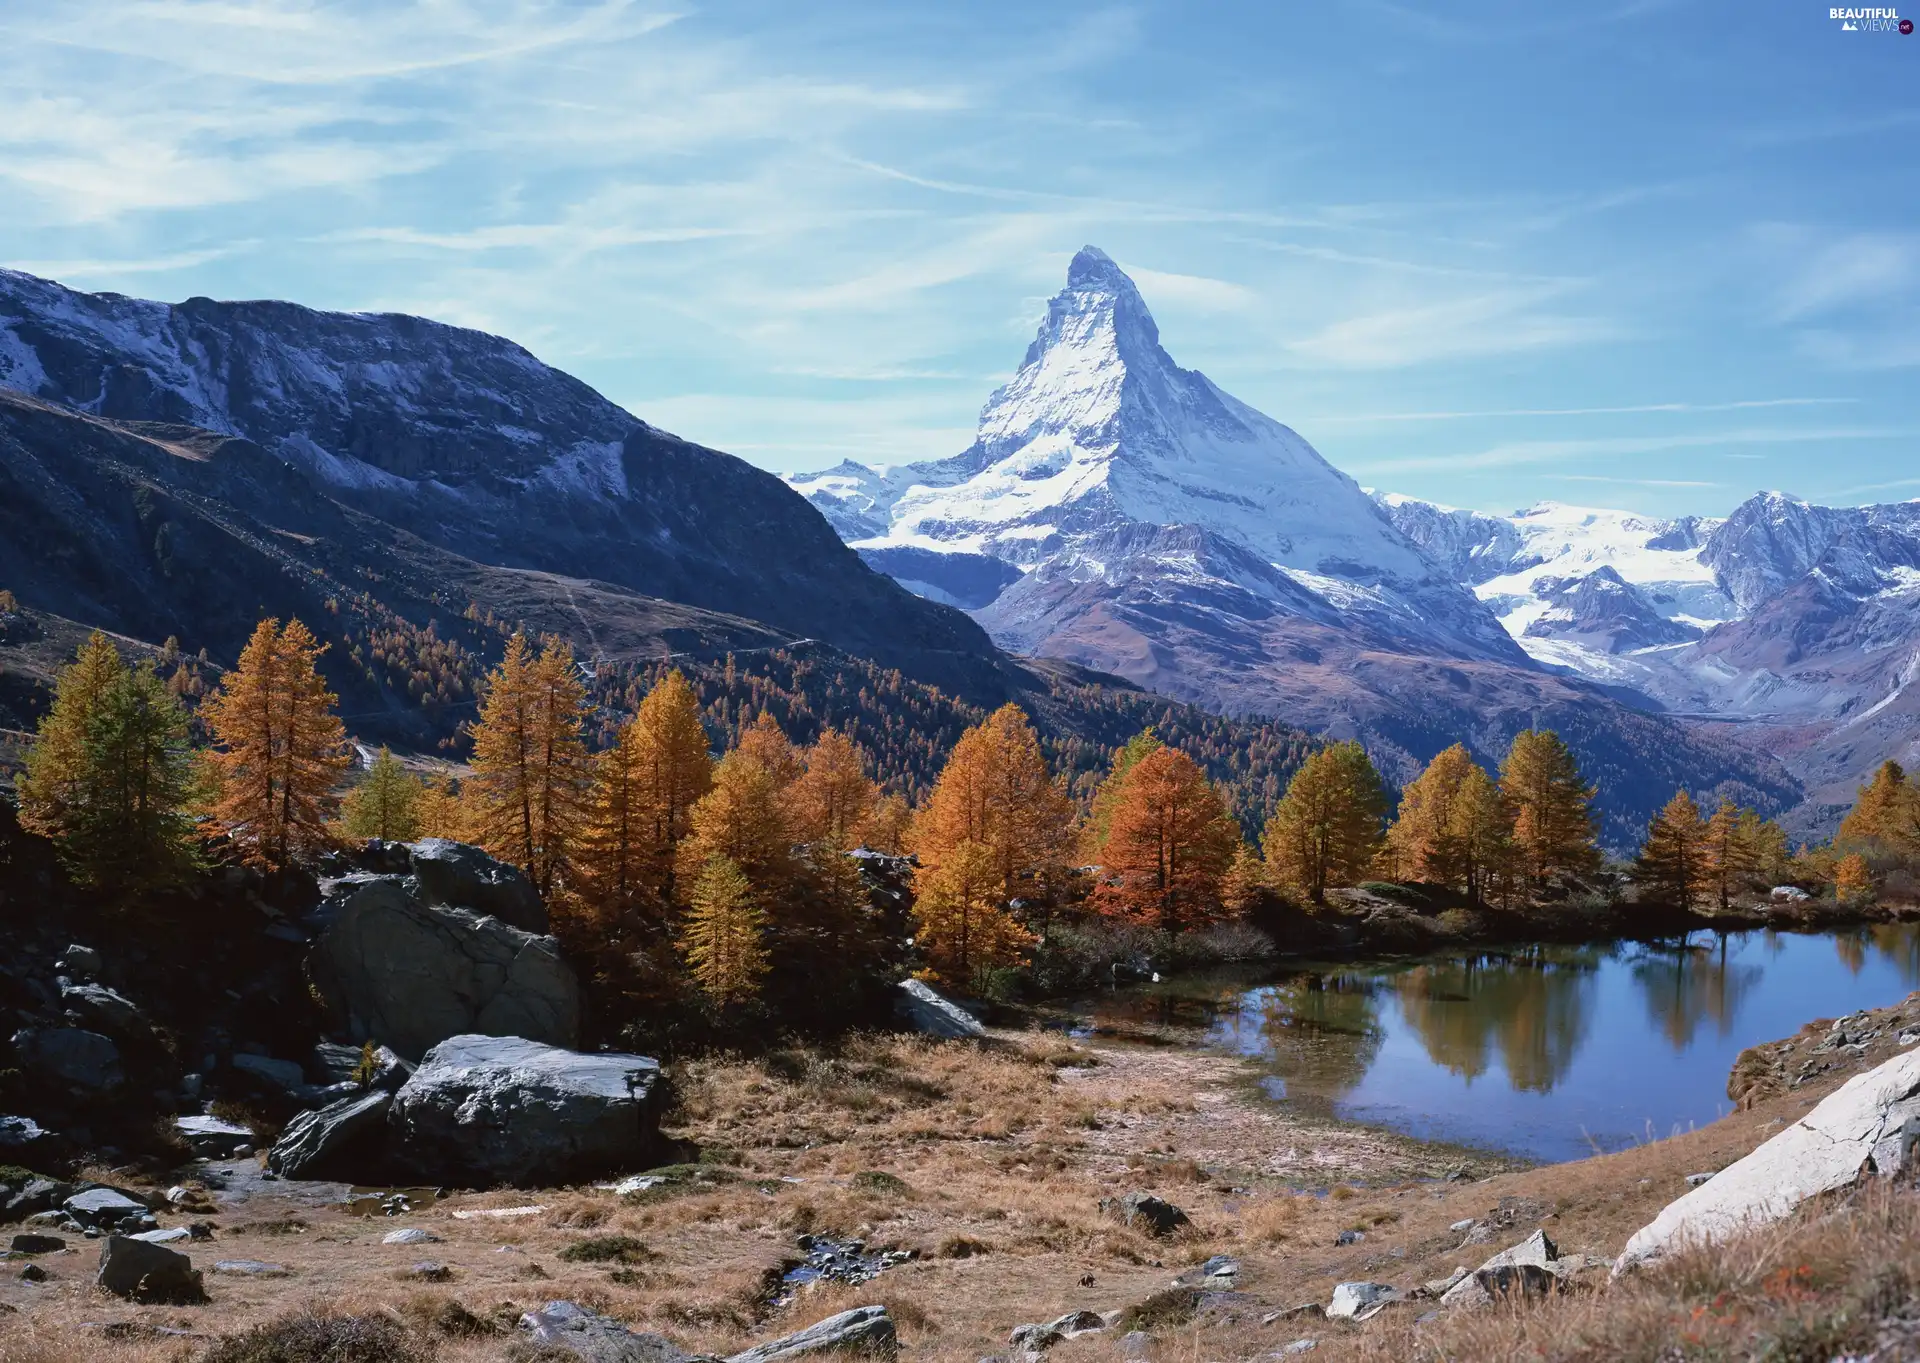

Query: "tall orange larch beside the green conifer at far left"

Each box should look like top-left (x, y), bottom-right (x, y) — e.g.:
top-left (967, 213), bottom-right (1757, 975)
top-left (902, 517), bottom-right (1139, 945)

top-left (200, 620), bottom-right (348, 870)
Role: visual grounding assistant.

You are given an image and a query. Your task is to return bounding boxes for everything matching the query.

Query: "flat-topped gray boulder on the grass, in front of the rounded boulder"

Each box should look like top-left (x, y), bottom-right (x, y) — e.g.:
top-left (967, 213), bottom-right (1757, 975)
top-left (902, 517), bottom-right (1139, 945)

top-left (388, 1037), bottom-right (660, 1188)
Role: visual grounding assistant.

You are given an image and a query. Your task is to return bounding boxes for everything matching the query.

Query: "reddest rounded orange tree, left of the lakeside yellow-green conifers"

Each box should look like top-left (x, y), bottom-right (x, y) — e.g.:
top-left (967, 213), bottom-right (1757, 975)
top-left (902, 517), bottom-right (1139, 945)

top-left (1094, 747), bottom-right (1242, 933)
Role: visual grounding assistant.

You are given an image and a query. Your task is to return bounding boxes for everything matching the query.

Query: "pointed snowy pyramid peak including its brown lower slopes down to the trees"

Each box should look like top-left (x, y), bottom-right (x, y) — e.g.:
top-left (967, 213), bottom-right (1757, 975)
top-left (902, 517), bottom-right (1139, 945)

top-left (789, 248), bottom-right (1795, 845)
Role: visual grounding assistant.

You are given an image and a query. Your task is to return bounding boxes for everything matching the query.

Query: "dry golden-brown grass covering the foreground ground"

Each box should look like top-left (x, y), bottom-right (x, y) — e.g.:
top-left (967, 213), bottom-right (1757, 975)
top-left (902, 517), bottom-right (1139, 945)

top-left (0, 998), bottom-right (1912, 1363)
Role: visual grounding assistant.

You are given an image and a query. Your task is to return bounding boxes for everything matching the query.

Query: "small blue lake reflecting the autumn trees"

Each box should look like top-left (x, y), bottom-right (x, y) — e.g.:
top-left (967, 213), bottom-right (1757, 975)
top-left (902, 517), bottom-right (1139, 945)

top-left (1092, 923), bottom-right (1920, 1160)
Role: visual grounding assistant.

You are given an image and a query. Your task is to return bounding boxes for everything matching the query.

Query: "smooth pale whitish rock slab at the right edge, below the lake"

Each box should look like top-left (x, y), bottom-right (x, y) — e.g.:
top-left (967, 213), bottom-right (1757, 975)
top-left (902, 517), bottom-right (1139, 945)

top-left (1613, 1048), bottom-right (1920, 1277)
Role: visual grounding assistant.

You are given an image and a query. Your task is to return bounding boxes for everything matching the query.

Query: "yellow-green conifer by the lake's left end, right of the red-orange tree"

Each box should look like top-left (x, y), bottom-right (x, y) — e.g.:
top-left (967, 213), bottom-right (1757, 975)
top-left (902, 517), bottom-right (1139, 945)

top-left (1260, 739), bottom-right (1386, 904)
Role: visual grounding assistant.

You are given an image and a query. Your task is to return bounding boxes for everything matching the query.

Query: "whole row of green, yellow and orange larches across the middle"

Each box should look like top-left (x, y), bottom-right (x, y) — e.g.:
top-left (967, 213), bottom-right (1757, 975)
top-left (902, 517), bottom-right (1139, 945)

top-left (17, 620), bottom-right (1920, 1006)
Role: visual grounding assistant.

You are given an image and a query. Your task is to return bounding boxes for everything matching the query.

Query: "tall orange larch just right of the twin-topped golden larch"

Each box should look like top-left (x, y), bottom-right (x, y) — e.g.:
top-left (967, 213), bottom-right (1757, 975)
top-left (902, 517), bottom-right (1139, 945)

top-left (576, 670), bottom-right (714, 918)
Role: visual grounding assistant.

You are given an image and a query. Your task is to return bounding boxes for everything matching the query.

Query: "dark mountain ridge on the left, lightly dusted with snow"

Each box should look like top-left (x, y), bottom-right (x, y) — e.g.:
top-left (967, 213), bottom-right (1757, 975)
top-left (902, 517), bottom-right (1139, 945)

top-left (0, 271), bottom-right (991, 685)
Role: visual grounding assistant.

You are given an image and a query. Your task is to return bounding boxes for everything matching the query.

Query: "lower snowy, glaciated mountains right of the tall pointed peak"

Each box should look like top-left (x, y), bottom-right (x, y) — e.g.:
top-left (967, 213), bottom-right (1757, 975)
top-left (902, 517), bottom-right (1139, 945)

top-left (1380, 491), bottom-right (1920, 829)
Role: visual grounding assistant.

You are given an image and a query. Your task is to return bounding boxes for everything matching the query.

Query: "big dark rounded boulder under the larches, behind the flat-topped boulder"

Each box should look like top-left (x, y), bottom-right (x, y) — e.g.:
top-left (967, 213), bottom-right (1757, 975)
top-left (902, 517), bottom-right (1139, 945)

top-left (309, 877), bottom-right (580, 1060)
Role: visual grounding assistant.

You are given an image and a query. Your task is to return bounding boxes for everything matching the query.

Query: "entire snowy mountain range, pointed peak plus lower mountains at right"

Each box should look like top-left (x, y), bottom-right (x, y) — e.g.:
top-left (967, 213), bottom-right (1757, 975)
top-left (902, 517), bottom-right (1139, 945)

top-left (789, 248), bottom-right (1920, 843)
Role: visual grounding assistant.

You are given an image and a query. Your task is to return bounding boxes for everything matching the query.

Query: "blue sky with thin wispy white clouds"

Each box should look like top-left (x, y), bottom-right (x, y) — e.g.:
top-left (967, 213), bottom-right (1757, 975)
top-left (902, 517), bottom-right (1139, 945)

top-left (0, 0), bottom-right (1920, 514)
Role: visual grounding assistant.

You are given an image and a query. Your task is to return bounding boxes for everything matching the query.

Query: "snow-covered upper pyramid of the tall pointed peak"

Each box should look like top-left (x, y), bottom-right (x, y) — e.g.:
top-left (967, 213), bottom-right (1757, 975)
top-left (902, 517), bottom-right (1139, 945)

top-left (789, 246), bottom-right (1519, 672)
